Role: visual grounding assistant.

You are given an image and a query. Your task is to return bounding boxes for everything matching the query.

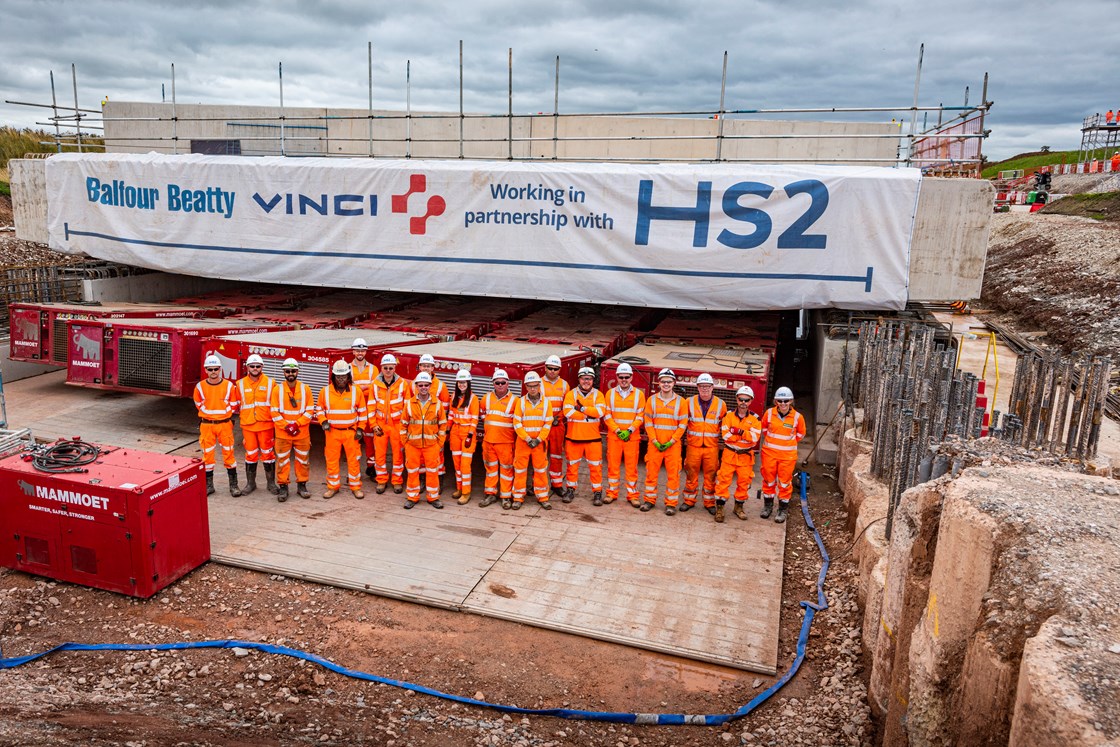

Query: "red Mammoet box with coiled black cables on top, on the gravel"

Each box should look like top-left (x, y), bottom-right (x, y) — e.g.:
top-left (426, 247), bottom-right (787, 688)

top-left (0, 447), bottom-right (211, 598)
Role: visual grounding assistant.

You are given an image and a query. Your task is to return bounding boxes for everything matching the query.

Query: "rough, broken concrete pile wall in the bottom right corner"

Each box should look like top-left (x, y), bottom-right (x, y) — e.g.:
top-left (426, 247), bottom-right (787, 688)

top-left (839, 429), bottom-right (1120, 747)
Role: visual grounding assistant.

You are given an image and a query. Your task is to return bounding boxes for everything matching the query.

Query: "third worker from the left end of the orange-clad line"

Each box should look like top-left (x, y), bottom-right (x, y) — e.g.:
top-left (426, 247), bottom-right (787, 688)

top-left (271, 358), bottom-right (315, 503)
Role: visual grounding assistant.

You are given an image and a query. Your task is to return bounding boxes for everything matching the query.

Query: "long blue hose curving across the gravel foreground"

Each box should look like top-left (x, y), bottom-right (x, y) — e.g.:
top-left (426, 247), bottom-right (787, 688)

top-left (0, 473), bottom-right (829, 726)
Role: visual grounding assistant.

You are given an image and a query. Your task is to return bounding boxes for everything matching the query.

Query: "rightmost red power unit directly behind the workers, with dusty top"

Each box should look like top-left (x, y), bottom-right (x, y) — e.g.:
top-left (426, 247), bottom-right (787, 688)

top-left (599, 343), bottom-right (773, 417)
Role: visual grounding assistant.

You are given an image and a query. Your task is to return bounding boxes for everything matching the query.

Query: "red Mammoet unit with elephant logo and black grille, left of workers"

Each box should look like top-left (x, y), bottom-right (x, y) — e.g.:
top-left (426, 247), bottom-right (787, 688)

top-left (66, 318), bottom-right (290, 396)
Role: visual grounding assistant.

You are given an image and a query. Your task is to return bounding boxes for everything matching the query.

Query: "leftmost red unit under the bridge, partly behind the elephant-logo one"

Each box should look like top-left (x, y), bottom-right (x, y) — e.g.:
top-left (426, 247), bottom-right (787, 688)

top-left (9, 302), bottom-right (206, 366)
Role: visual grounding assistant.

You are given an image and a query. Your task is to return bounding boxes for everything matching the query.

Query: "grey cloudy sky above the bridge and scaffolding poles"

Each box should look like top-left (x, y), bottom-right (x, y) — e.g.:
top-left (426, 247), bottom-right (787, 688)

top-left (0, 0), bottom-right (1120, 160)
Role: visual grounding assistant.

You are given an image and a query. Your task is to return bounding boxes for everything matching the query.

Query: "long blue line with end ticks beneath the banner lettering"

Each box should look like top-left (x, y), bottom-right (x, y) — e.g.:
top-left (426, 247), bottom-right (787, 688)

top-left (63, 223), bottom-right (875, 293)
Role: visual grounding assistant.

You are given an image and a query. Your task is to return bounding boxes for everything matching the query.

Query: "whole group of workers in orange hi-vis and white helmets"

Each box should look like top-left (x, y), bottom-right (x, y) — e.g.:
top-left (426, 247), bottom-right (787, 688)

top-left (194, 338), bottom-right (805, 523)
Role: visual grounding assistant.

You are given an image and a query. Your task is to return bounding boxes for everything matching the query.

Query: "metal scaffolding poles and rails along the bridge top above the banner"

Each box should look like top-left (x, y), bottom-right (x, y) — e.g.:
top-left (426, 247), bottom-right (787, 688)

top-left (7, 40), bottom-right (992, 167)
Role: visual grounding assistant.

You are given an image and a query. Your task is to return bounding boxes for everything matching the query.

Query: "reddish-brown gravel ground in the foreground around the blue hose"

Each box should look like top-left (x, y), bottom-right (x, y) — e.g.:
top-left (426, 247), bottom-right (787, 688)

top-left (0, 463), bottom-right (875, 747)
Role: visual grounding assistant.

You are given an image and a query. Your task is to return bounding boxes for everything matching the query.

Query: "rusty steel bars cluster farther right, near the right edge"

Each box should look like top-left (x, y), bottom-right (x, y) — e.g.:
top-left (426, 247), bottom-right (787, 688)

top-left (992, 351), bottom-right (1112, 460)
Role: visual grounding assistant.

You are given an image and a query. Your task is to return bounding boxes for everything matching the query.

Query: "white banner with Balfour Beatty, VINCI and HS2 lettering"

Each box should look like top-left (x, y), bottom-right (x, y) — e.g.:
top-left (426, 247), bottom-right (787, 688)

top-left (47, 153), bottom-right (921, 309)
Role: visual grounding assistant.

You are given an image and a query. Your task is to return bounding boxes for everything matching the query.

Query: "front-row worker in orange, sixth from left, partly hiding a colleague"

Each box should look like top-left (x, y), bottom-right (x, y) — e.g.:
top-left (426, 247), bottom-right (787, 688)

top-left (401, 372), bottom-right (447, 508)
